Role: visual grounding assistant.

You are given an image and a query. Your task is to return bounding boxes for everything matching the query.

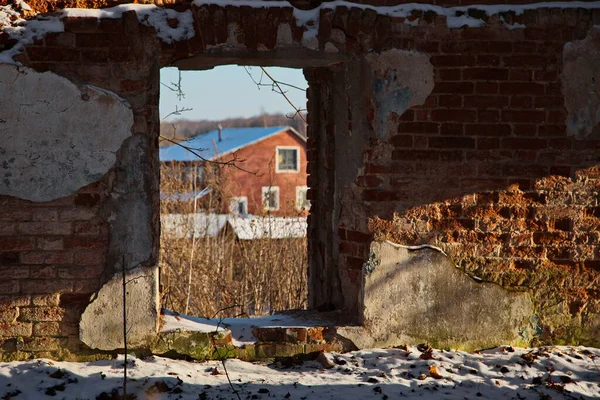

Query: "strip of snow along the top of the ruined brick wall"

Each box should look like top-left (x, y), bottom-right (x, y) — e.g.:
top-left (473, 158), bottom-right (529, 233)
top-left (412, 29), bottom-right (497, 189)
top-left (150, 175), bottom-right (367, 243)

top-left (0, 0), bottom-right (600, 64)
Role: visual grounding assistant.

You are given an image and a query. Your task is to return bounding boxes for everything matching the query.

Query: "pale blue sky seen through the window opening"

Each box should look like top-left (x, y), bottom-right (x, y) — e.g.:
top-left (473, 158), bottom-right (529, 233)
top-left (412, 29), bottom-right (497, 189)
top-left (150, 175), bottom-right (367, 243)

top-left (160, 65), bottom-right (308, 121)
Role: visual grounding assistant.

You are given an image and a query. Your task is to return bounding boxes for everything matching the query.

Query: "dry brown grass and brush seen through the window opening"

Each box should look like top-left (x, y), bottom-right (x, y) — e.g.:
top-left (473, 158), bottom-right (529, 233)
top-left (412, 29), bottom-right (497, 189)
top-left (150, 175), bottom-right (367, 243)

top-left (160, 161), bottom-right (308, 317)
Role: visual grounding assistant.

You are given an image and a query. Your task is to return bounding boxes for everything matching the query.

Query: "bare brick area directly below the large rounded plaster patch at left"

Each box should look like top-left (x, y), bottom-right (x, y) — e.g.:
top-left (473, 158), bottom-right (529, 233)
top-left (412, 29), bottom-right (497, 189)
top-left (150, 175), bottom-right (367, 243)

top-left (0, 179), bottom-right (109, 352)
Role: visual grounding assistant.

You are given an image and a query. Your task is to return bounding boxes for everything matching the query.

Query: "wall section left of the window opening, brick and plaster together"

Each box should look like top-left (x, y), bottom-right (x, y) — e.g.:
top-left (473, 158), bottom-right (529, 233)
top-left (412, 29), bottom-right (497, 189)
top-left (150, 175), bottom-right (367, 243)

top-left (0, 11), bottom-right (159, 358)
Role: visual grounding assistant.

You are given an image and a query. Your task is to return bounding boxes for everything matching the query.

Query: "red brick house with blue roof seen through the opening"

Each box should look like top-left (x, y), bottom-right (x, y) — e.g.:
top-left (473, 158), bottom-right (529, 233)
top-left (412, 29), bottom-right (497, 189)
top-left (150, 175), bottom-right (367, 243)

top-left (160, 126), bottom-right (310, 217)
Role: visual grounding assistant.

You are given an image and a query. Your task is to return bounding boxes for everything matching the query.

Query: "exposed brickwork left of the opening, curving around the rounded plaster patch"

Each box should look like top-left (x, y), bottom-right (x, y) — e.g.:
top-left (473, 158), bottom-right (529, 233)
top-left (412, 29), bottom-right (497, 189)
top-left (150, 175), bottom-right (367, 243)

top-left (0, 15), bottom-right (159, 358)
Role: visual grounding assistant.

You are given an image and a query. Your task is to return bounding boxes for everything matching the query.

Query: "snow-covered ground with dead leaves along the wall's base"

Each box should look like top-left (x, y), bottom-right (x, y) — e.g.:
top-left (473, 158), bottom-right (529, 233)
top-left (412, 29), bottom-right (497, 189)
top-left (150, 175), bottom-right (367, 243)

top-left (0, 346), bottom-right (600, 400)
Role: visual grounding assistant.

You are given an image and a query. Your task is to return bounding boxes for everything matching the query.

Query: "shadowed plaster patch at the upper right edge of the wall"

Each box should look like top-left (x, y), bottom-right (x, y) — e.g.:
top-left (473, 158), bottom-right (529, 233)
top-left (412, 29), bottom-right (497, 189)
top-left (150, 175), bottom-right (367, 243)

top-left (561, 29), bottom-right (600, 138)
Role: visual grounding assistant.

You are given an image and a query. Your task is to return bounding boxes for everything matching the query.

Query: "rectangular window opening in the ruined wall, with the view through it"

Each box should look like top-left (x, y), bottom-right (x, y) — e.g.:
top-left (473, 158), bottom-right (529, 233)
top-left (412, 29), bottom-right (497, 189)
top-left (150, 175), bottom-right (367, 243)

top-left (159, 66), bottom-right (310, 317)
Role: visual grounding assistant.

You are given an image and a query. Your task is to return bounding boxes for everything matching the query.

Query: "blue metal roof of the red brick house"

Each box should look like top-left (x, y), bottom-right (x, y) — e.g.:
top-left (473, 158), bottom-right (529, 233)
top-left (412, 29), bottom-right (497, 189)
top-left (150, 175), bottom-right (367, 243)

top-left (159, 126), bottom-right (289, 161)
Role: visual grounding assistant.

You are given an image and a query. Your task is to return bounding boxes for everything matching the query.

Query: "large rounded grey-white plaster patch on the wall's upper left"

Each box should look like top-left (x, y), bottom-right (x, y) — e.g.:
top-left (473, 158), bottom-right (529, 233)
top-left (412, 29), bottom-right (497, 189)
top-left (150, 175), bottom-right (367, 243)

top-left (0, 65), bottom-right (133, 202)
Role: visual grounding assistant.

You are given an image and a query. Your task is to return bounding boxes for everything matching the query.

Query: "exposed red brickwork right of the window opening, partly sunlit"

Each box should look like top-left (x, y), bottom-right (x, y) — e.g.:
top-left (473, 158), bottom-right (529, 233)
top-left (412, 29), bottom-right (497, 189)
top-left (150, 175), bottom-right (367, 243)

top-left (334, 10), bottom-right (600, 343)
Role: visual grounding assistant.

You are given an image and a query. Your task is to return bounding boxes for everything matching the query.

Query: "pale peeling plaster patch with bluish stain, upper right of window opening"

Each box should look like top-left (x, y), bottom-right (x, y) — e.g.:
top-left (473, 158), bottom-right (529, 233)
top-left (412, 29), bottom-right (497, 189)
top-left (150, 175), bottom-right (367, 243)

top-left (366, 49), bottom-right (434, 139)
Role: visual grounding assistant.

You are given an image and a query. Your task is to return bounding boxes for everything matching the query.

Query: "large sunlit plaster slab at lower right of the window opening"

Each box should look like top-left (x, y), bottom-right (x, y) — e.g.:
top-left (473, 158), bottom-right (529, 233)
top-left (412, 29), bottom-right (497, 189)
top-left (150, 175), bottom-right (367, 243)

top-left (358, 241), bottom-right (533, 350)
